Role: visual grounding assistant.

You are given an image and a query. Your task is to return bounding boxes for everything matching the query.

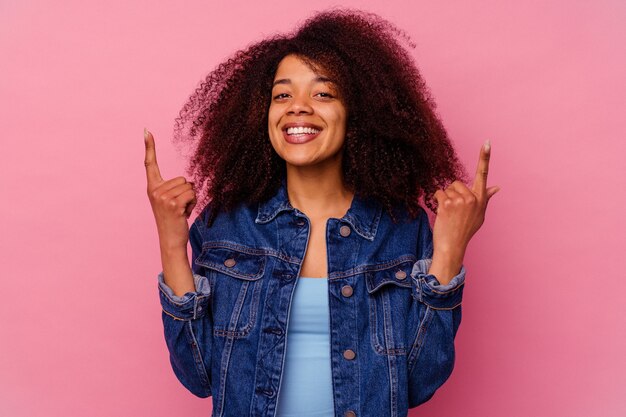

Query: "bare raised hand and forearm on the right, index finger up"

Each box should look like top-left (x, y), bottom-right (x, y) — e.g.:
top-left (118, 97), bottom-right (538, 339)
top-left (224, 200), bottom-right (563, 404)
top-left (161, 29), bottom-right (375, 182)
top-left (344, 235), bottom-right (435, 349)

top-left (429, 141), bottom-right (500, 284)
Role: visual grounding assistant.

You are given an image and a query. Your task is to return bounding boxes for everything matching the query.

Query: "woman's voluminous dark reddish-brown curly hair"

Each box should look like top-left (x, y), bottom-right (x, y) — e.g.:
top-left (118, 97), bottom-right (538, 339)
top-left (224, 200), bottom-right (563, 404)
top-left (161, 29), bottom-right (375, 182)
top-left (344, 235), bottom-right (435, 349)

top-left (174, 9), bottom-right (466, 222)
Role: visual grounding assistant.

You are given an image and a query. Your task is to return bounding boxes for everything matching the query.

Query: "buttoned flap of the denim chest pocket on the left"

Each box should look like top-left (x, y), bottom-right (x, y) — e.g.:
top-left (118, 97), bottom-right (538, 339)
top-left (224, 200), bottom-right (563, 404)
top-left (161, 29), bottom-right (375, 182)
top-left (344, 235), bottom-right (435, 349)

top-left (195, 247), bottom-right (265, 281)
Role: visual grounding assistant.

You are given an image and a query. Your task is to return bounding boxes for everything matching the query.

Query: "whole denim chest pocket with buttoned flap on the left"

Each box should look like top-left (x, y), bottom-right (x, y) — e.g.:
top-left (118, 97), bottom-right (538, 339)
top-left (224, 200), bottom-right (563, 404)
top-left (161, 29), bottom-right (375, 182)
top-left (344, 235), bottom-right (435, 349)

top-left (195, 248), bottom-right (266, 338)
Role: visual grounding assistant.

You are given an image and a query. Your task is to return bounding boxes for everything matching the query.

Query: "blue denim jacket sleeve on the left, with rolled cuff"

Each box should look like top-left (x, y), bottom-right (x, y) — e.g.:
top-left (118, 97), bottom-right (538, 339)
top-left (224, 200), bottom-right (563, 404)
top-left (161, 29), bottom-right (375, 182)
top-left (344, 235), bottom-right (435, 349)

top-left (158, 216), bottom-right (213, 398)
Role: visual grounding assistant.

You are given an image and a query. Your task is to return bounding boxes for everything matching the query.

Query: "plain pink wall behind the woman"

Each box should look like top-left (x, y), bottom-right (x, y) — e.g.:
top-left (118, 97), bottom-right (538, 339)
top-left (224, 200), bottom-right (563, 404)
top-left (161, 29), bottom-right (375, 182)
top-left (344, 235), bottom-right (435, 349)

top-left (0, 0), bottom-right (626, 417)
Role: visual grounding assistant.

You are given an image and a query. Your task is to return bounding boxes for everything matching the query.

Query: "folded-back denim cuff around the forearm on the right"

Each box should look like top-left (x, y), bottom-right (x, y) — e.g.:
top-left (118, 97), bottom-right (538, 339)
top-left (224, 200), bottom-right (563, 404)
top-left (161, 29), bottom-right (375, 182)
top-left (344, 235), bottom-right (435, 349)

top-left (411, 259), bottom-right (465, 310)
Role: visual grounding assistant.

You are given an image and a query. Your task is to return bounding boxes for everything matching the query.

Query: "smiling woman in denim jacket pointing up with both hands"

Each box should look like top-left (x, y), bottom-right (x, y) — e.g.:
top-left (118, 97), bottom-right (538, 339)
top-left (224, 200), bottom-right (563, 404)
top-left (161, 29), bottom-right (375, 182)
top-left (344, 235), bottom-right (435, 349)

top-left (145, 10), bottom-right (498, 417)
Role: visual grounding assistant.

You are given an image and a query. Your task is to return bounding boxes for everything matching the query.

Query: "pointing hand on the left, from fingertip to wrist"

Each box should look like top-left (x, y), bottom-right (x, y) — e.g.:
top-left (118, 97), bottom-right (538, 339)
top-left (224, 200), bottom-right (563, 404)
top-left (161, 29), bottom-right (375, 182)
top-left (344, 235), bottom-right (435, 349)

top-left (144, 129), bottom-right (197, 251)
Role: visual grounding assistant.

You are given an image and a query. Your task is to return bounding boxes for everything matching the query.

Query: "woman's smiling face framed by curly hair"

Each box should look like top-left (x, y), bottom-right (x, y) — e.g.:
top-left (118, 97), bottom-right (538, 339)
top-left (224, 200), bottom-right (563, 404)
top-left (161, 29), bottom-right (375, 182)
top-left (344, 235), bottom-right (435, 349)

top-left (268, 55), bottom-right (346, 167)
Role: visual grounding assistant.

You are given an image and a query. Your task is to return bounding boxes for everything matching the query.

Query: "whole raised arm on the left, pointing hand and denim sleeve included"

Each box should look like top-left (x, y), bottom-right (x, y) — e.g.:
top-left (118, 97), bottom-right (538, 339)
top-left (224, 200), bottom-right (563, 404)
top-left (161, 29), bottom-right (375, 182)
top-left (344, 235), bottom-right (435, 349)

top-left (144, 130), bottom-right (213, 397)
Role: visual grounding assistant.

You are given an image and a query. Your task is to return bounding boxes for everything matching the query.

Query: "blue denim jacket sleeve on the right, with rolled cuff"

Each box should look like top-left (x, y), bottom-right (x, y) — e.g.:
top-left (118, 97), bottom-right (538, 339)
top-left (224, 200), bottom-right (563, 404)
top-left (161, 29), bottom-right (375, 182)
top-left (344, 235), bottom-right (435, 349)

top-left (409, 210), bottom-right (465, 408)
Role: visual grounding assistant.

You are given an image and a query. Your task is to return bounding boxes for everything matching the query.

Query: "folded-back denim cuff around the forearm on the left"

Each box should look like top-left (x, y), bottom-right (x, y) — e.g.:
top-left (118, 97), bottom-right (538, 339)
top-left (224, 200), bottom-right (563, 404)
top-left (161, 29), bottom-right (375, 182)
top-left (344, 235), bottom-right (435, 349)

top-left (158, 272), bottom-right (211, 320)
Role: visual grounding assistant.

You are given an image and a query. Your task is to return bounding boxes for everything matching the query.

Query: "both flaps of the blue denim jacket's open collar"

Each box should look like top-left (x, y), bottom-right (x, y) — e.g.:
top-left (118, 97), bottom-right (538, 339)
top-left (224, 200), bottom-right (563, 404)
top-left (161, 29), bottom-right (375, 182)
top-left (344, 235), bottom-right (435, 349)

top-left (255, 179), bottom-right (382, 240)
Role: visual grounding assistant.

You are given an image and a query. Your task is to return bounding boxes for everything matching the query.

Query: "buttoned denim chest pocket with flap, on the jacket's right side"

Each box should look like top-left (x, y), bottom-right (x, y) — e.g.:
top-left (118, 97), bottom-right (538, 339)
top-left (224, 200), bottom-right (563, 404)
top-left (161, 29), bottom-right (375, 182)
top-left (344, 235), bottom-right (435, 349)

top-left (365, 261), bottom-right (419, 355)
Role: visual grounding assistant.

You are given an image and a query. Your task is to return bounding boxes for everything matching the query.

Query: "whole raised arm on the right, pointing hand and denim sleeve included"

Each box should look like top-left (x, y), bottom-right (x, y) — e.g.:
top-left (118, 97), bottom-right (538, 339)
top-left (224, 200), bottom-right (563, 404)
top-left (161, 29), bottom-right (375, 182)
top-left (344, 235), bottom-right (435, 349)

top-left (409, 142), bottom-right (499, 407)
